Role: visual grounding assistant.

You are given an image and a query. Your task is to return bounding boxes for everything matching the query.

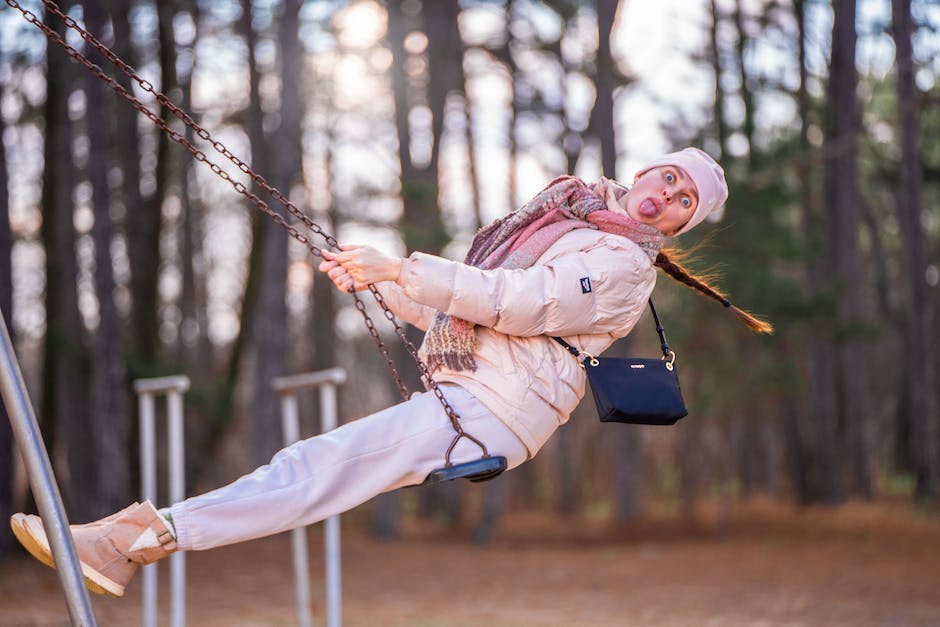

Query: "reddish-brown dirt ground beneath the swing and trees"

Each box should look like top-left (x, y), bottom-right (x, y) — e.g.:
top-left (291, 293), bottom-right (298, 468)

top-left (0, 501), bottom-right (940, 627)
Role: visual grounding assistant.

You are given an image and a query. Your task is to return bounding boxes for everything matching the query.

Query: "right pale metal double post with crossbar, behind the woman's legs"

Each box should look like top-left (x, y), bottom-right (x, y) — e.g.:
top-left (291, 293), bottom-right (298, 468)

top-left (273, 368), bottom-right (346, 627)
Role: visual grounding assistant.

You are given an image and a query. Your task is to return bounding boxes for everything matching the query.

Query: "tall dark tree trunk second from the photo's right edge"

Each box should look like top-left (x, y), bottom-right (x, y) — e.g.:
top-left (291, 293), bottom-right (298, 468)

top-left (824, 0), bottom-right (874, 498)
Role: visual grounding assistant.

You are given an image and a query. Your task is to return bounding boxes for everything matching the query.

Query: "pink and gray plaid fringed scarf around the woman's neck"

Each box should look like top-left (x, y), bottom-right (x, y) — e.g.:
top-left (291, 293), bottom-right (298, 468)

top-left (423, 176), bottom-right (663, 373)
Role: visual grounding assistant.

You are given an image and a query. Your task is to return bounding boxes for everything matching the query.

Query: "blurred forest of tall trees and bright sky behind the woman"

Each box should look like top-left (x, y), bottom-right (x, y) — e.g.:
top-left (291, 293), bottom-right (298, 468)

top-left (0, 0), bottom-right (940, 550)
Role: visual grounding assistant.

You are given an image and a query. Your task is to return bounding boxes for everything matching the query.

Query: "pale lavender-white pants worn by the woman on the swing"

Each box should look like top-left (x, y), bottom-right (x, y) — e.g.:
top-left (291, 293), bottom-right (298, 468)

top-left (170, 385), bottom-right (527, 550)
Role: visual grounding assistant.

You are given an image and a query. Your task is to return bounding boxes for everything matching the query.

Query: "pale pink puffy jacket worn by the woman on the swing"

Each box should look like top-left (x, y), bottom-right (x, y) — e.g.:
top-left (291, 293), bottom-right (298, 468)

top-left (378, 228), bottom-right (656, 457)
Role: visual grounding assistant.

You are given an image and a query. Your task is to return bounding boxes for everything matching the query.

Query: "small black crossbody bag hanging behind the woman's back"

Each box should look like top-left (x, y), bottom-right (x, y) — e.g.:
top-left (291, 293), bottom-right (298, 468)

top-left (552, 298), bottom-right (689, 425)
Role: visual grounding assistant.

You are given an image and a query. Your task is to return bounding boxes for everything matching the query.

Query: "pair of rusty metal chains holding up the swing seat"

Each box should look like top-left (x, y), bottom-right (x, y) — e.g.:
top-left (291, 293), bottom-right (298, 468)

top-left (12, 0), bottom-right (488, 452)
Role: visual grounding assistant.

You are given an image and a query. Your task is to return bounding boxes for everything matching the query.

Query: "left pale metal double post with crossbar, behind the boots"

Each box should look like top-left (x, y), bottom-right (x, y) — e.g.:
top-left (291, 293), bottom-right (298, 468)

top-left (134, 375), bottom-right (189, 627)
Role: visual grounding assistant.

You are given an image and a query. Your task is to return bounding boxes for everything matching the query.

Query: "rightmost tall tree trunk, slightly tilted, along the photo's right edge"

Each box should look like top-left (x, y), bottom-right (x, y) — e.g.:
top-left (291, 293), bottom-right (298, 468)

top-left (891, 0), bottom-right (940, 501)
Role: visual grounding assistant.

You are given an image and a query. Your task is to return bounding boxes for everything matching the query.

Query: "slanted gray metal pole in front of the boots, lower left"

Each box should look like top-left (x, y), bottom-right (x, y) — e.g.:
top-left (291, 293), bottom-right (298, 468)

top-left (0, 312), bottom-right (97, 627)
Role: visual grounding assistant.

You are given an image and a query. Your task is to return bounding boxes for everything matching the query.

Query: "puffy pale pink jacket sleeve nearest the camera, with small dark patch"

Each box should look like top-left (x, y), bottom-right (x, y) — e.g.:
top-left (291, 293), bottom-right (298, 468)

top-left (398, 240), bottom-right (656, 336)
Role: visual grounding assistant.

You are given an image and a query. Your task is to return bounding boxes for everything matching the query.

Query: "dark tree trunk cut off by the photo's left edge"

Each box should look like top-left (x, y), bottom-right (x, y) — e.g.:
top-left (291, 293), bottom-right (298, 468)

top-left (0, 78), bottom-right (13, 557)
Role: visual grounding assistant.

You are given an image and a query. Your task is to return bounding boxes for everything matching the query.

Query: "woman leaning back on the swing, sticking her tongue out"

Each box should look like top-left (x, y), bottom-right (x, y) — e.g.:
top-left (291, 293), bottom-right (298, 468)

top-left (11, 148), bottom-right (770, 596)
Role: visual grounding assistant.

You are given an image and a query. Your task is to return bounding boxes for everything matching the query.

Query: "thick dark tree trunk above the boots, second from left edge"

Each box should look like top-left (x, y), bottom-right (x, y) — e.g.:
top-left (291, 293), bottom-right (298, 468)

top-left (39, 14), bottom-right (95, 519)
